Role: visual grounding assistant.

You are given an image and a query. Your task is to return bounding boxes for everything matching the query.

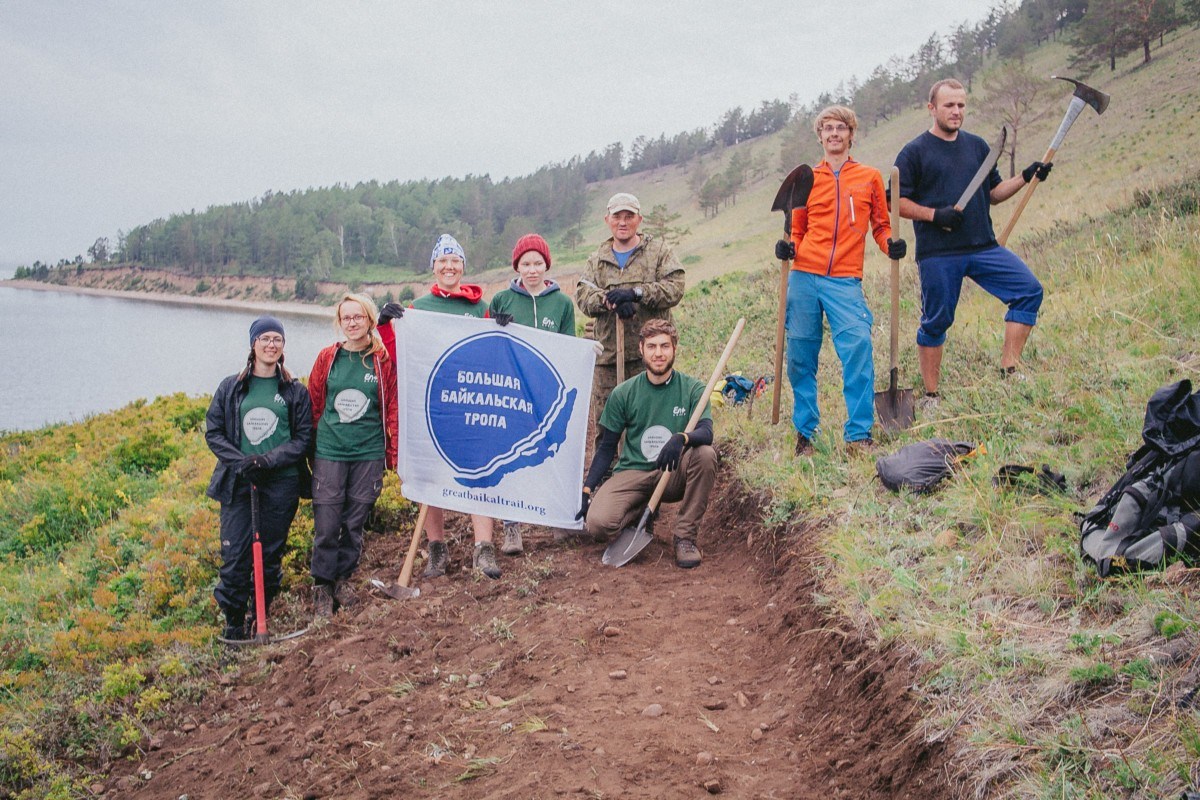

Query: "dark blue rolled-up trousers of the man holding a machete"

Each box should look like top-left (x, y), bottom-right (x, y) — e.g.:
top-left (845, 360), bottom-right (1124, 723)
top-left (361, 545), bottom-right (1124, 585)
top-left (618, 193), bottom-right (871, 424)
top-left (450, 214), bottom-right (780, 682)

top-left (917, 245), bottom-right (1042, 347)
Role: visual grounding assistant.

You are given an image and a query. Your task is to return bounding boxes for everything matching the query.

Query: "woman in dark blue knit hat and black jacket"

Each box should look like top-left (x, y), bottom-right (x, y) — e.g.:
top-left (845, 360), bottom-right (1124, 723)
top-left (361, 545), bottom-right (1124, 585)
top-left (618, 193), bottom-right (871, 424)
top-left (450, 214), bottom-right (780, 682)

top-left (204, 317), bottom-right (312, 642)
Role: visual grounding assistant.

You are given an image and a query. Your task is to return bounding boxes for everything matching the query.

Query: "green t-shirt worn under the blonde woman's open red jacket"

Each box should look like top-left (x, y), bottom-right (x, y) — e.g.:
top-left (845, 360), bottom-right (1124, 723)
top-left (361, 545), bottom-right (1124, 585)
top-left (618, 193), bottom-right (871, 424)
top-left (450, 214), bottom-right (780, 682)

top-left (317, 348), bottom-right (384, 461)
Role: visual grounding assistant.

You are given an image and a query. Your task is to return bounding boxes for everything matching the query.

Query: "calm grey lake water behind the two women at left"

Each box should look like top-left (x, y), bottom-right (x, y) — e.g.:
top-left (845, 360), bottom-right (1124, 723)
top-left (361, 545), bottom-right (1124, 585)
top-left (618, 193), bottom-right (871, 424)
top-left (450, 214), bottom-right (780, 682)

top-left (0, 281), bottom-right (337, 431)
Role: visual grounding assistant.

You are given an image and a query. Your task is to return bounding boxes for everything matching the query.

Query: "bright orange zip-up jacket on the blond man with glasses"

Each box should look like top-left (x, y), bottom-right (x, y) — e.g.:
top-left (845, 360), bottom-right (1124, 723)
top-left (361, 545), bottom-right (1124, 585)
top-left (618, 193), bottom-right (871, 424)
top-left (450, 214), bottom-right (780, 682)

top-left (792, 158), bottom-right (892, 278)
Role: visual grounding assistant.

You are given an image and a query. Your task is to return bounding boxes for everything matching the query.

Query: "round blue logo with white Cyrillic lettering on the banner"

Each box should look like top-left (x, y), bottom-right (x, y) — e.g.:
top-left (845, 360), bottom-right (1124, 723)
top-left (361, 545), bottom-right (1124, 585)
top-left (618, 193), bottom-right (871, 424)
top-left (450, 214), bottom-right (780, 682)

top-left (425, 331), bottom-right (578, 487)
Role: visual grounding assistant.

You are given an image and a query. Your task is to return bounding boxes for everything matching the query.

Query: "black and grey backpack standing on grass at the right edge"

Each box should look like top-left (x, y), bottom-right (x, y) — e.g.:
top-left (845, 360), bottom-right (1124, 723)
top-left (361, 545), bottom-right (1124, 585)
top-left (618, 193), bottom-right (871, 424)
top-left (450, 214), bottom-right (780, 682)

top-left (1079, 380), bottom-right (1200, 577)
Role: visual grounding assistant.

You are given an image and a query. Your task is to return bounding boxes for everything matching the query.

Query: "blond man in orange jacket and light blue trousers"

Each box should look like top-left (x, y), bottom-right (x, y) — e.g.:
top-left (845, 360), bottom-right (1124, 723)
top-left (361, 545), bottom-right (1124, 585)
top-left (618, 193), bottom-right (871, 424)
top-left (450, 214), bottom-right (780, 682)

top-left (775, 106), bottom-right (907, 456)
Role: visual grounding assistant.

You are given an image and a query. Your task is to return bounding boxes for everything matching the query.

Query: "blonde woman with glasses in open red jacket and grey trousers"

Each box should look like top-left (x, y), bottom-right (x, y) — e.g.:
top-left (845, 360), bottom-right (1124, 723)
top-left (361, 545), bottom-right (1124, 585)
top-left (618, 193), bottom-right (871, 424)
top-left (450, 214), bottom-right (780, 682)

top-left (308, 294), bottom-right (397, 618)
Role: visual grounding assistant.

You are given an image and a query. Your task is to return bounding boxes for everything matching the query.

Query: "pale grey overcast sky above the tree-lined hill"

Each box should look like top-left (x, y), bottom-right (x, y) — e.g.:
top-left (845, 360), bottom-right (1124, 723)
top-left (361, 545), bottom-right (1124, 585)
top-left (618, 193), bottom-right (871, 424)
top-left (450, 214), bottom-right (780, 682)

top-left (0, 0), bottom-right (994, 264)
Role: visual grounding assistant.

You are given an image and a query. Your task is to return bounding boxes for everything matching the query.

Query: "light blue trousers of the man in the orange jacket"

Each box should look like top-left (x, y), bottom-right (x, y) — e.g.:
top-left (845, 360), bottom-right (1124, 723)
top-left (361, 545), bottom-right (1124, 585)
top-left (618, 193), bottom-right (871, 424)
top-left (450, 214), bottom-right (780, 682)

top-left (787, 270), bottom-right (875, 441)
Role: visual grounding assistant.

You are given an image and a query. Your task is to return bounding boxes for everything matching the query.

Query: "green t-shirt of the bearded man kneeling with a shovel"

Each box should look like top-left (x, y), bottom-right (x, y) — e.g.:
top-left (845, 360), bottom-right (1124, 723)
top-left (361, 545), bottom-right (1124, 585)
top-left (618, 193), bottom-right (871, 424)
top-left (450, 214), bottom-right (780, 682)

top-left (600, 369), bottom-right (713, 473)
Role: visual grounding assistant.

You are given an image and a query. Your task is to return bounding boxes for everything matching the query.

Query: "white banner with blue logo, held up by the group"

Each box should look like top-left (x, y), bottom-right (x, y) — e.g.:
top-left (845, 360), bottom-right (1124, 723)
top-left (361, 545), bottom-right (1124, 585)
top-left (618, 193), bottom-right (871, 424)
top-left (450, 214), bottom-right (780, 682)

top-left (392, 308), bottom-right (595, 528)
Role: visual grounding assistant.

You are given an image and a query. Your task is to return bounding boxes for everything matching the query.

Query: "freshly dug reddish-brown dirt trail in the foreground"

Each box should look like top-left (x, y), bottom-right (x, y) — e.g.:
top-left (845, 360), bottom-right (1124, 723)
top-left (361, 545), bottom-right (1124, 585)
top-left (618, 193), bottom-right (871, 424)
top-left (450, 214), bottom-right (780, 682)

top-left (106, 489), bottom-right (954, 800)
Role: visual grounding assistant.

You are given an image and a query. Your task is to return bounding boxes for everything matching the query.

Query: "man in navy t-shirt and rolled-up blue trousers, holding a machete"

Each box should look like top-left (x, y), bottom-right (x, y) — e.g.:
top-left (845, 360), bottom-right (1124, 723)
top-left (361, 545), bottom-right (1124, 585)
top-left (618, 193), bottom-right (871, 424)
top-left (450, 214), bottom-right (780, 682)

top-left (895, 78), bottom-right (1051, 410)
